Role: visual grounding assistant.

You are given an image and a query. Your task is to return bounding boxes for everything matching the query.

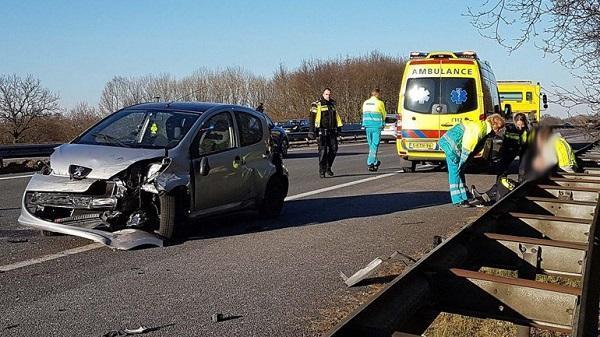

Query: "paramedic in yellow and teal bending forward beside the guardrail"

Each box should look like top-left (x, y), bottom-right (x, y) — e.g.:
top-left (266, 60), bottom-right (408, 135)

top-left (439, 114), bottom-right (504, 207)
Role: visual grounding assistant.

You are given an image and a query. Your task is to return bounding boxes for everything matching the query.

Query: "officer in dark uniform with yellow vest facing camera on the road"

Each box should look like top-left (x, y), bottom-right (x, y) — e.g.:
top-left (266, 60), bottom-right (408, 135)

top-left (309, 88), bottom-right (342, 178)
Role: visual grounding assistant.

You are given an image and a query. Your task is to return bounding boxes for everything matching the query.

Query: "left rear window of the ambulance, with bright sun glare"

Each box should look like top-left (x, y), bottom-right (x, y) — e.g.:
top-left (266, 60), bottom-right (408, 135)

top-left (404, 78), bottom-right (439, 113)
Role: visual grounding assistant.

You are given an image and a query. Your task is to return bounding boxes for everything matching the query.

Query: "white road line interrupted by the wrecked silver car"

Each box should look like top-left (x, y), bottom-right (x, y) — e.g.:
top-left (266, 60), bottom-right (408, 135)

top-left (0, 171), bottom-right (402, 272)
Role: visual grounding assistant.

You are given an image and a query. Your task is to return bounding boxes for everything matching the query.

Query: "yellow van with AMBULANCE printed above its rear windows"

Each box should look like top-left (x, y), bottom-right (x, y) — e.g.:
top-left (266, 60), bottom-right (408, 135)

top-left (396, 51), bottom-right (500, 171)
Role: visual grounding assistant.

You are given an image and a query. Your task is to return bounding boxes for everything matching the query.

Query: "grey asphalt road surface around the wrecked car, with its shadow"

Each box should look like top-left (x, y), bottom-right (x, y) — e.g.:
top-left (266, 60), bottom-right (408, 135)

top-left (0, 144), bottom-right (502, 336)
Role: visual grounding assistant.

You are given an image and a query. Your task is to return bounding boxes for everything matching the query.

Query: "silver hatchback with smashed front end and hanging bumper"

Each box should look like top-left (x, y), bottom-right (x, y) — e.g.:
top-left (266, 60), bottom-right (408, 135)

top-left (19, 103), bottom-right (288, 249)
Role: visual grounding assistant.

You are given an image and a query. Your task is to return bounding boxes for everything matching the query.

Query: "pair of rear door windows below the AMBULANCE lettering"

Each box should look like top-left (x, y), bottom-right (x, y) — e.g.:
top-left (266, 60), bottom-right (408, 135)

top-left (404, 77), bottom-right (477, 114)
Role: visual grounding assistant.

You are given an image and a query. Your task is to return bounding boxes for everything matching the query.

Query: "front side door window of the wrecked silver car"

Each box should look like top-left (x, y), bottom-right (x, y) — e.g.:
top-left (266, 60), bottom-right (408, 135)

top-left (198, 111), bottom-right (234, 155)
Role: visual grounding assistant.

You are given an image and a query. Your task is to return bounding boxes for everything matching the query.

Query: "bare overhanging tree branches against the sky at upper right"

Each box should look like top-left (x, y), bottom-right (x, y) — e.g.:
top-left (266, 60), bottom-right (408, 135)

top-left (467, 0), bottom-right (600, 113)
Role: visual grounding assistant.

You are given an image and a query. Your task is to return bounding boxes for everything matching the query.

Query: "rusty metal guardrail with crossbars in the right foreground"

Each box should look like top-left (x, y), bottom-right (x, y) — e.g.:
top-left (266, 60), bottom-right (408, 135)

top-left (328, 145), bottom-right (600, 337)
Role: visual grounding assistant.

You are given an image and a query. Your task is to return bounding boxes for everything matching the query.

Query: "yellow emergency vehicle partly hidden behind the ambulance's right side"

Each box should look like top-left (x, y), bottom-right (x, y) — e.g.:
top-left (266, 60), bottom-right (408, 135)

top-left (498, 81), bottom-right (548, 125)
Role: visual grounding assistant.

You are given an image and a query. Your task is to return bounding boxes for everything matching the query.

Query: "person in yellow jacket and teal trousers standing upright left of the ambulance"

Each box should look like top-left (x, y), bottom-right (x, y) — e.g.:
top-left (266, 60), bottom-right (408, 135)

top-left (362, 88), bottom-right (386, 172)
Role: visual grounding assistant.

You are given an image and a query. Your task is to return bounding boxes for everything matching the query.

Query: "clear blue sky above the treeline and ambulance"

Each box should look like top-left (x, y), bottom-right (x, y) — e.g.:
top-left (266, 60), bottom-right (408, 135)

top-left (0, 0), bottom-right (574, 115)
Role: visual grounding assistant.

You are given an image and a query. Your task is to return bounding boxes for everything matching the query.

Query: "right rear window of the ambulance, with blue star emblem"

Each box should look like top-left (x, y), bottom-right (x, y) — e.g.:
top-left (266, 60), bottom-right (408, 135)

top-left (440, 78), bottom-right (477, 114)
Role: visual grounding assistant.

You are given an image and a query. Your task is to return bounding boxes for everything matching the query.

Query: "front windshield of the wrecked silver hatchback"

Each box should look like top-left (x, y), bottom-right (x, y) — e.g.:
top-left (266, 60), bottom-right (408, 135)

top-left (74, 109), bottom-right (199, 149)
